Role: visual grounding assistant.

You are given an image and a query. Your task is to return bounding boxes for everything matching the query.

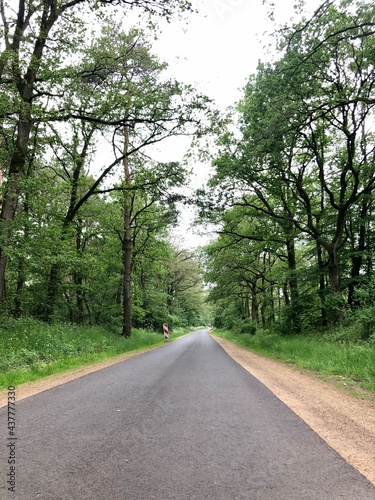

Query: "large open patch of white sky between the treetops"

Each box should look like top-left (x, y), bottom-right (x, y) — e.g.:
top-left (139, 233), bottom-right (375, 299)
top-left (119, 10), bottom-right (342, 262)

top-left (154, 0), bottom-right (265, 107)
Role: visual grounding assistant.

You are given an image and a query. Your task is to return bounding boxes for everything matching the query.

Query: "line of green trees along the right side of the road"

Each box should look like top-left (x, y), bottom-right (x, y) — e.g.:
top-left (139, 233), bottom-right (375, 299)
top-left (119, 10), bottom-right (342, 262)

top-left (199, 1), bottom-right (375, 337)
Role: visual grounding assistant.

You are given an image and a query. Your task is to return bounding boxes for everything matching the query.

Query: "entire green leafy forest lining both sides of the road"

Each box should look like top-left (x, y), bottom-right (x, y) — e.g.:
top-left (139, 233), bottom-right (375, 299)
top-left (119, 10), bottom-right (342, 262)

top-left (0, 0), bottom-right (375, 352)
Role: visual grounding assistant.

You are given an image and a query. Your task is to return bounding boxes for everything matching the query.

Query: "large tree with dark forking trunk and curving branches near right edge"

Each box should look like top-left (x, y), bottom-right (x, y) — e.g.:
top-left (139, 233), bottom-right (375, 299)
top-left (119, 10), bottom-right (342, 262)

top-left (278, 3), bottom-right (375, 293)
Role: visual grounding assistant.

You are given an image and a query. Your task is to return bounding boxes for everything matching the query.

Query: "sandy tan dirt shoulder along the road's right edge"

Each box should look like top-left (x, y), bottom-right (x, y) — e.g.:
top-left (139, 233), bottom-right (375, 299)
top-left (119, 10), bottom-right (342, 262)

top-left (211, 334), bottom-right (375, 485)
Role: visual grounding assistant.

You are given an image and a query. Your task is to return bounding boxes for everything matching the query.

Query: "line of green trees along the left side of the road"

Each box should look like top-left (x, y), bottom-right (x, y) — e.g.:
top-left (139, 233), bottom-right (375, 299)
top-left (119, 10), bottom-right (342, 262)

top-left (0, 0), bottom-right (213, 336)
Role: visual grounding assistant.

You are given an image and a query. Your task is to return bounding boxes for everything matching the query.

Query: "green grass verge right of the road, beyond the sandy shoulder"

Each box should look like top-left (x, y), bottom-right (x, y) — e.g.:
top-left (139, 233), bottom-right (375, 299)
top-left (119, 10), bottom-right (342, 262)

top-left (213, 330), bottom-right (375, 392)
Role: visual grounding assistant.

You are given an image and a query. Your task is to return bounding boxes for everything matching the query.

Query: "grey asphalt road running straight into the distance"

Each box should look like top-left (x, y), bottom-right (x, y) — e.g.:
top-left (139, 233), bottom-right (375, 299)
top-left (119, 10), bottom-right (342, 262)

top-left (0, 330), bottom-right (375, 500)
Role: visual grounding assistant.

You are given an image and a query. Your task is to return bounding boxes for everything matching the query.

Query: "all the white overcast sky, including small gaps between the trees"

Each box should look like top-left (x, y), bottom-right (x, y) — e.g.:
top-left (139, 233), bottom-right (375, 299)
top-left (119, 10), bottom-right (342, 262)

top-left (145, 0), bottom-right (324, 247)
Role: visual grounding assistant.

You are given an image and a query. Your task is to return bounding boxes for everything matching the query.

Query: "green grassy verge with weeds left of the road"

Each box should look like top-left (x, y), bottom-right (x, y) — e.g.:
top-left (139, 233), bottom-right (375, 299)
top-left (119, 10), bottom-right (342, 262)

top-left (0, 318), bottom-right (190, 390)
